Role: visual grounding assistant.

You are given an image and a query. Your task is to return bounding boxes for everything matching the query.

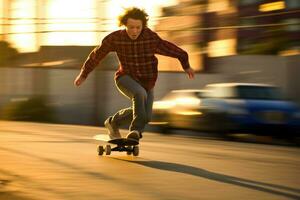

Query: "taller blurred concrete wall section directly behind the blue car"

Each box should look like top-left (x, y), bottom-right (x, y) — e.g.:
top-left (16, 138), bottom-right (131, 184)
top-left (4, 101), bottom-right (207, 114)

top-left (211, 55), bottom-right (300, 102)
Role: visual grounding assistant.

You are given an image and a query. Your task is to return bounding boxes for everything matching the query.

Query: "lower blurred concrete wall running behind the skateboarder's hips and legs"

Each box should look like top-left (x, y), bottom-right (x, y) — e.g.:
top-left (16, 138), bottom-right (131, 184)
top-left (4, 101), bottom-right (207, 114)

top-left (0, 68), bottom-right (226, 124)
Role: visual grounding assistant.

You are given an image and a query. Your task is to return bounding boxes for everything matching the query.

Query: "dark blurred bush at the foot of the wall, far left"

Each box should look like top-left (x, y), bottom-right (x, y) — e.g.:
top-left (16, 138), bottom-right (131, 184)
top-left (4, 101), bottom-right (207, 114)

top-left (0, 97), bottom-right (55, 122)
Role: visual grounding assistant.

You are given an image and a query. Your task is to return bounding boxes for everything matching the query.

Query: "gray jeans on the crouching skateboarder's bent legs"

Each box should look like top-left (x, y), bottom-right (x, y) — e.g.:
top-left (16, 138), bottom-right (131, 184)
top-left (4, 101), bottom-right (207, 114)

top-left (112, 75), bottom-right (153, 133)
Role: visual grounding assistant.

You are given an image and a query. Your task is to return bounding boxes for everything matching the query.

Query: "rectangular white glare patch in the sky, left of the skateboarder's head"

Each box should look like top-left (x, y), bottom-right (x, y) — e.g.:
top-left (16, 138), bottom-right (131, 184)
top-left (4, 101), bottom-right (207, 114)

top-left (44, 0), bottom-right (96, 45)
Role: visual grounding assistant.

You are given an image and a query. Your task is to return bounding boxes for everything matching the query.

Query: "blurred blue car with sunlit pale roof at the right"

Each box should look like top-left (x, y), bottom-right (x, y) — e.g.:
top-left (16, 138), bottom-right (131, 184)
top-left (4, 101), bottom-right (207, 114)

top-left (200, 83), bottom-right (300, 137)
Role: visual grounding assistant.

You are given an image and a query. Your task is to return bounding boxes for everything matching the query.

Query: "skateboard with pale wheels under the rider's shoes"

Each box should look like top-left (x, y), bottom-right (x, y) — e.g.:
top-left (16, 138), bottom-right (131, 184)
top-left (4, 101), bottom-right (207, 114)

top-left (98, 138), bottom-right (139, 156)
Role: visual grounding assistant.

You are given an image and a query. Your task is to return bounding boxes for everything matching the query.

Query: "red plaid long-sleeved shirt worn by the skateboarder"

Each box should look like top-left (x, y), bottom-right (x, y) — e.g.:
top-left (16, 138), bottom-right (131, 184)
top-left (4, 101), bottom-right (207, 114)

top-left (81, 28), bottom-right (190, 90)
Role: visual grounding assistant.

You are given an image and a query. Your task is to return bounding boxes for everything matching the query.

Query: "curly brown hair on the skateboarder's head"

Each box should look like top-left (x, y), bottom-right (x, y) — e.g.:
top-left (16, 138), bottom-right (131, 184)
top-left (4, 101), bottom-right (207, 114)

top-left (119, 7), bottom-right (149, 27)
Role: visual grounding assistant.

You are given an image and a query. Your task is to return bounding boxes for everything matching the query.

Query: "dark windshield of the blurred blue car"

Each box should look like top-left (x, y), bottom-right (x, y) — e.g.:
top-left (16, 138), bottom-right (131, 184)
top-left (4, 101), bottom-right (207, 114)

top-left (236, 86), bottom-right (283, 100)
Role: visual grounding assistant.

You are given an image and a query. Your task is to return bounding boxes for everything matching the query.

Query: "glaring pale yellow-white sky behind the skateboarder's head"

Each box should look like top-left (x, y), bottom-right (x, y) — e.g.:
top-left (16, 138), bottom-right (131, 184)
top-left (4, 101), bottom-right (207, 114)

top-left (0, 0), bottom-right (177, 52)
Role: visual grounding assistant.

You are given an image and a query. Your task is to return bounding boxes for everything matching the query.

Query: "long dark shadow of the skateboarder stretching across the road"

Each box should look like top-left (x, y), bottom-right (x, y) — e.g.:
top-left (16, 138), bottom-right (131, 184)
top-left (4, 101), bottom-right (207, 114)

top-left (114, 158), bottom-right (300, 199)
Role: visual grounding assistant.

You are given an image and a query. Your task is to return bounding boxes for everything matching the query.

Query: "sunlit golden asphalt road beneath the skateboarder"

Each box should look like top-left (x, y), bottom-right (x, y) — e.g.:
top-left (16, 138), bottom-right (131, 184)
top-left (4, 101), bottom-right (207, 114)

top-left (0, 121), bottom-right (300, 200)
